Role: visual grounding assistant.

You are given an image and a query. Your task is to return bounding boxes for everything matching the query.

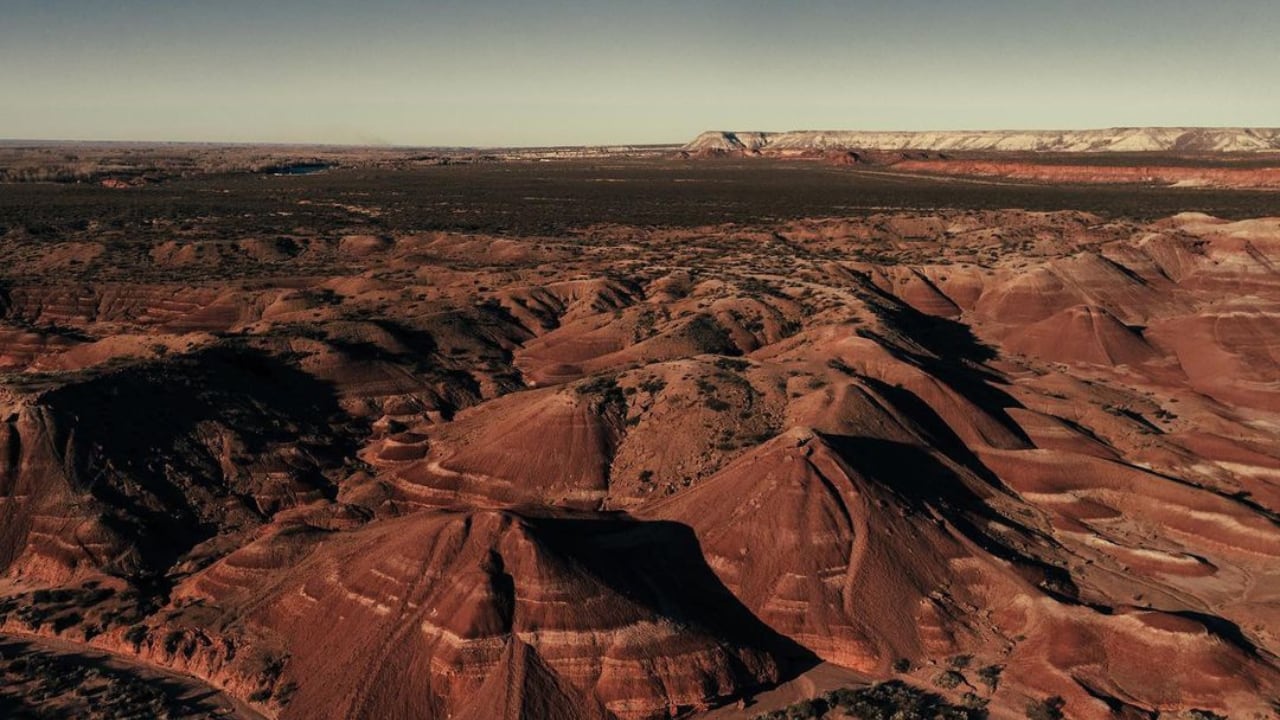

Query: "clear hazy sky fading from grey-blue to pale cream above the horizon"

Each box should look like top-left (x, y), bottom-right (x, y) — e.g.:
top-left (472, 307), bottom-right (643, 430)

top-left (0, 0), bottom-right (1280, 146)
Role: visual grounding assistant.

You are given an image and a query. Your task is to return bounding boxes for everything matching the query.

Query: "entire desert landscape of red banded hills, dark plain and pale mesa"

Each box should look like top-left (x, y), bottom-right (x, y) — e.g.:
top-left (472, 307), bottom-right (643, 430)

top-left (0, 128), bottom-right (1280, 720)
